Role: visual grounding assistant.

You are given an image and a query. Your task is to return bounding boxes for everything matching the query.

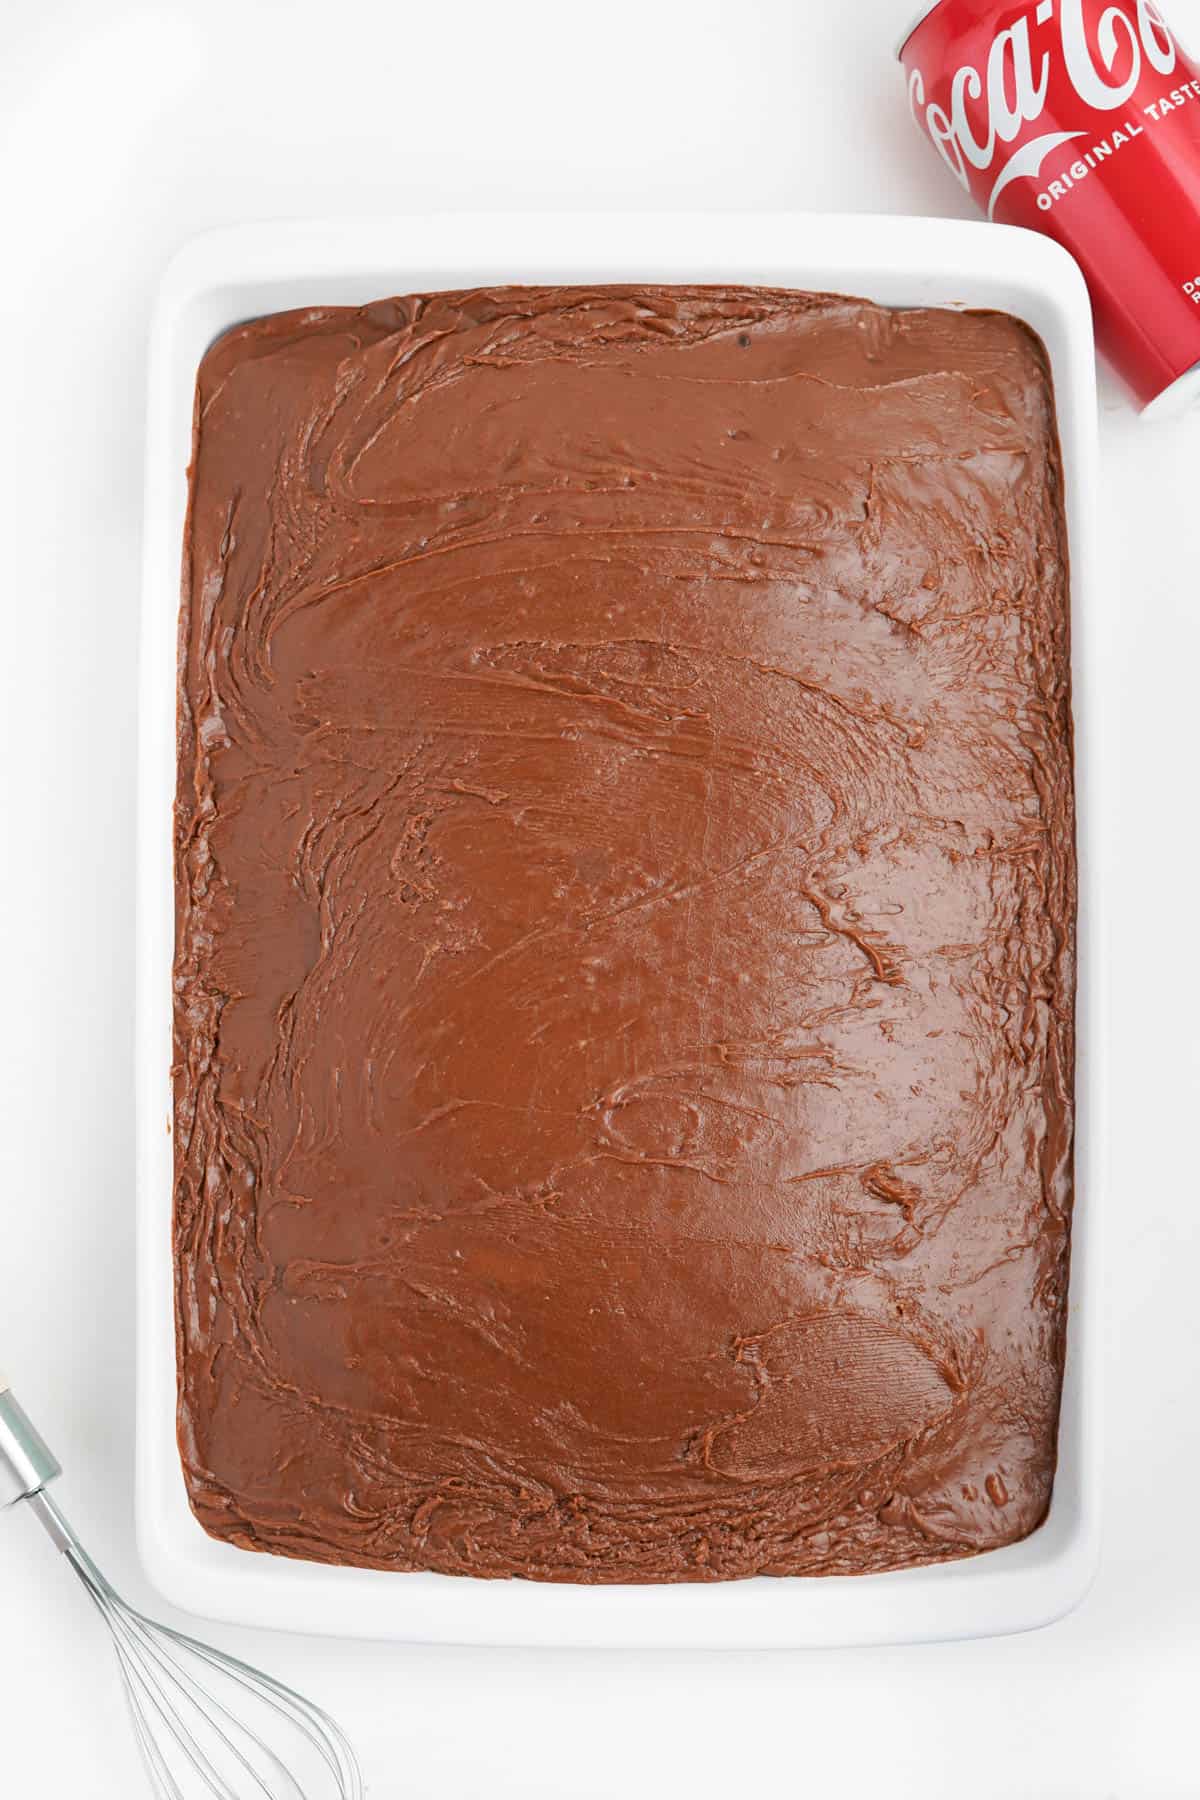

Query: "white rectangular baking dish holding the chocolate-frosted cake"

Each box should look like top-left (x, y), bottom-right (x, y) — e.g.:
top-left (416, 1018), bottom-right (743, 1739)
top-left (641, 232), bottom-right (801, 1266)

top-left (137, 214), bottom-right (1112, 1649)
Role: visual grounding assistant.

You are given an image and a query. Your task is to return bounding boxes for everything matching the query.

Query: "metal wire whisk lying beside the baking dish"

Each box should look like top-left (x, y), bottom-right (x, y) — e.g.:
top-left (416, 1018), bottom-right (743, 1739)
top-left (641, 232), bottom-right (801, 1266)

top-left (0, 1375), bottom-right (363, 1800)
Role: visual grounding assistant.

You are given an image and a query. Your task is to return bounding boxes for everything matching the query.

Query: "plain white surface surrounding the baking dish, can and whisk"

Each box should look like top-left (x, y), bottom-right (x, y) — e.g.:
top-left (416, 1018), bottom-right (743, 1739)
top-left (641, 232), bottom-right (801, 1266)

top-left (0, 0), bottom-right (1200, 1800)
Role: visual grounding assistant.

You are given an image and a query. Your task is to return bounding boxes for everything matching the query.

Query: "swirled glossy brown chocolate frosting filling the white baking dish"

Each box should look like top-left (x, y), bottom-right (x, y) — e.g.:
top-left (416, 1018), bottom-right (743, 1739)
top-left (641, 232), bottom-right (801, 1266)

top-left (175, 286), bottom-right (1076, 1582)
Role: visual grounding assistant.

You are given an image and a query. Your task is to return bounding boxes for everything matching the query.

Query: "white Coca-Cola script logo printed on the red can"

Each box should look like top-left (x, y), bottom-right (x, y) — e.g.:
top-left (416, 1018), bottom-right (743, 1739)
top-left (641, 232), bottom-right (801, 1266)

top-left (909, 0), bottom-right (1178, 218)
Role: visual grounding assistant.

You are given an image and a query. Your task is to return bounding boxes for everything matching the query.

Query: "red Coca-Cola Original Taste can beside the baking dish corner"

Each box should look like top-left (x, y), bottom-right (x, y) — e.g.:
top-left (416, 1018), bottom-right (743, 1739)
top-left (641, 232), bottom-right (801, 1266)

top-left (900, 0), bottom-right (1200, 407)
